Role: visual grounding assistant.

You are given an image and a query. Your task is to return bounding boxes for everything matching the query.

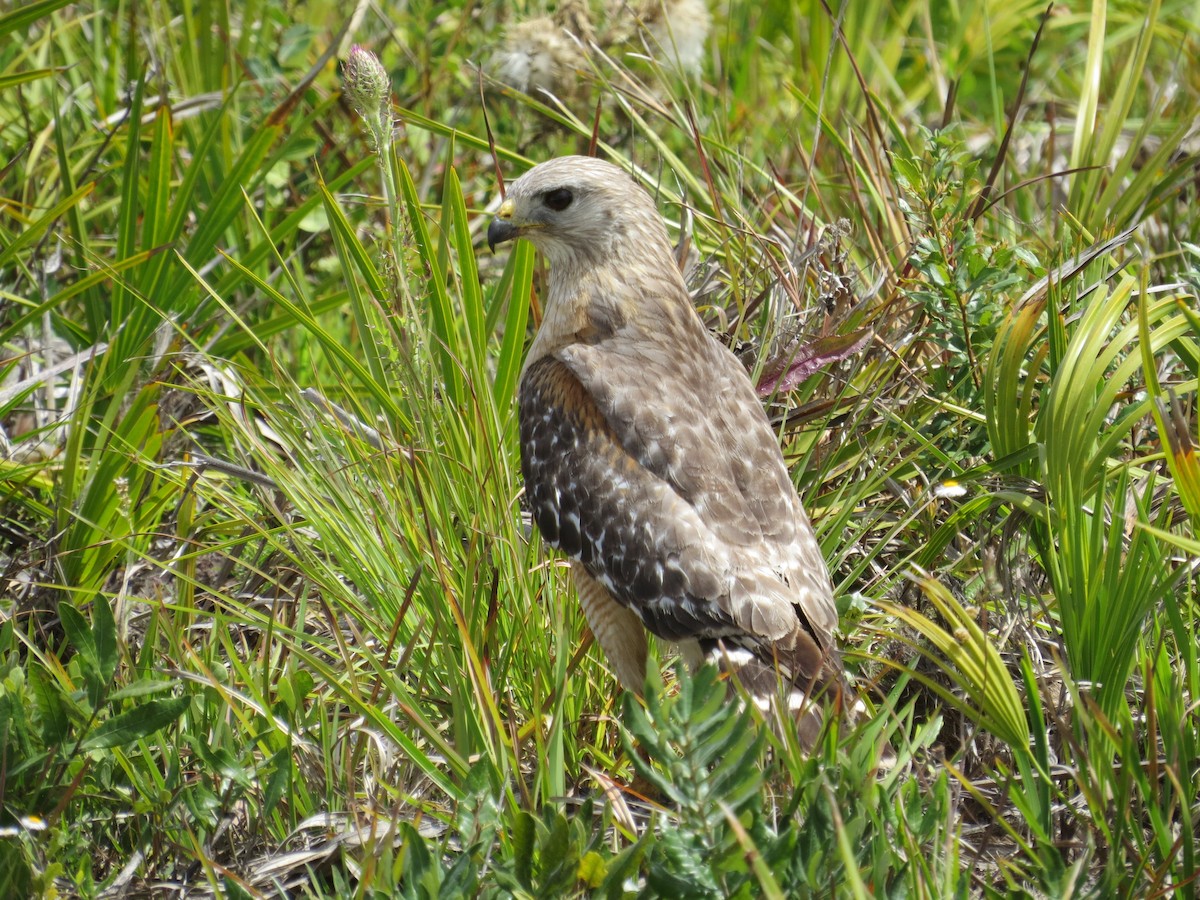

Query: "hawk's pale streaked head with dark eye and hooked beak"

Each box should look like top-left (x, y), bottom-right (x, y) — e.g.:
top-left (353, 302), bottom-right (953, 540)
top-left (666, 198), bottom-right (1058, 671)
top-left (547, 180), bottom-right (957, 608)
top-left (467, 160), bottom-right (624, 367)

top-left (487, 156), bottom-right (671, 266)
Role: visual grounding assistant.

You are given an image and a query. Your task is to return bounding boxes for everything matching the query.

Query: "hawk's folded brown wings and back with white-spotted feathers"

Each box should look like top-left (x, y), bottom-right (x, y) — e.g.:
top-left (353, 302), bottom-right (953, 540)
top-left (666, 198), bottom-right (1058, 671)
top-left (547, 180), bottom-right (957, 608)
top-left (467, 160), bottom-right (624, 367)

top-left (520, 323), bottom-right (836, 680)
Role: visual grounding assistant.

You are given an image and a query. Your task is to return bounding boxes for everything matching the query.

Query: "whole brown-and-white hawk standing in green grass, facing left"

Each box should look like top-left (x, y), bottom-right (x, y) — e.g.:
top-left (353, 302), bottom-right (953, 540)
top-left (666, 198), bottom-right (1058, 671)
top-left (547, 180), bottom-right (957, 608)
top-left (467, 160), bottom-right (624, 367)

top-left (487, 156), bottom-right (842, 743)
